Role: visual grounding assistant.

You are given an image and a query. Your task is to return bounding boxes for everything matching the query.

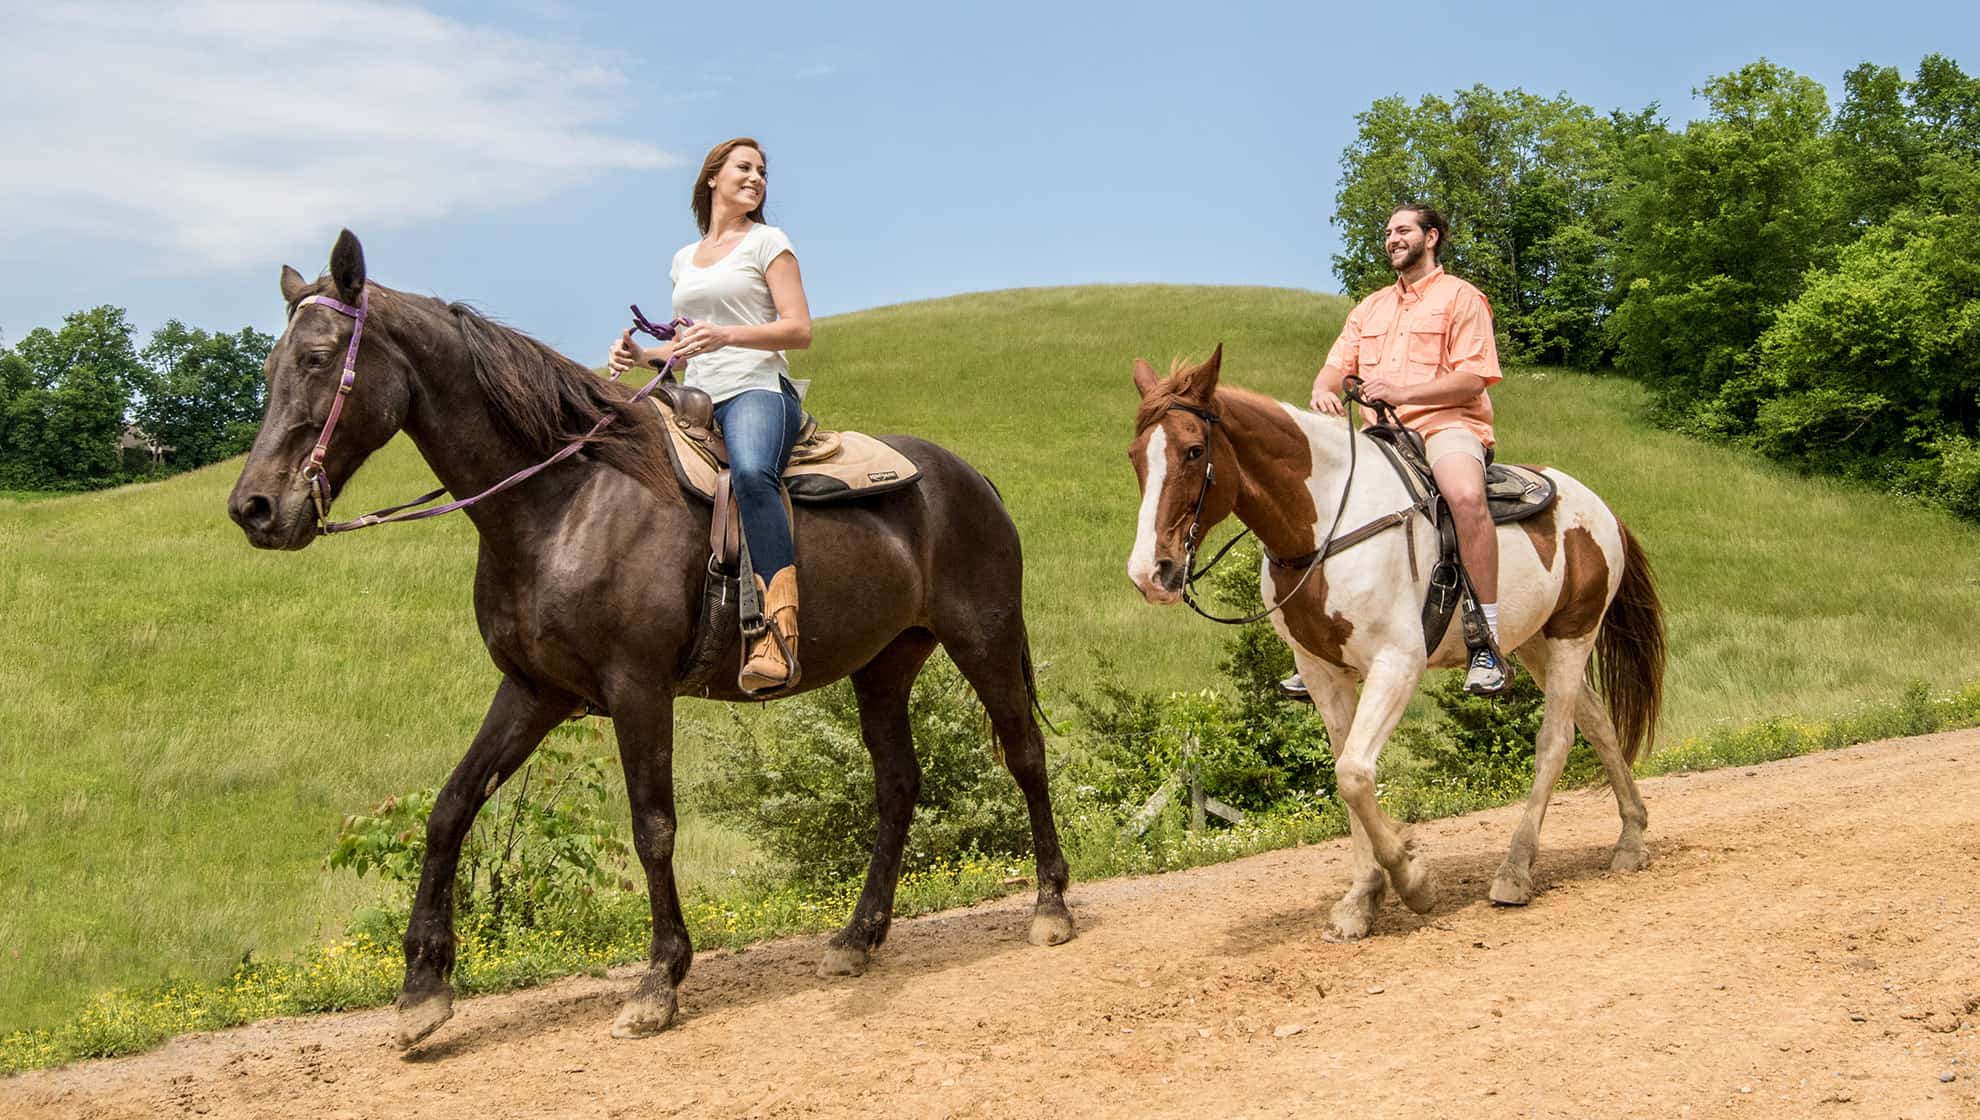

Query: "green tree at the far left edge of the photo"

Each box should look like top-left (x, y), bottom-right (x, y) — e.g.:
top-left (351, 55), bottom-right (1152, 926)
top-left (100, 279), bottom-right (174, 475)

top-left (0, 305), bottom-right (141, 489)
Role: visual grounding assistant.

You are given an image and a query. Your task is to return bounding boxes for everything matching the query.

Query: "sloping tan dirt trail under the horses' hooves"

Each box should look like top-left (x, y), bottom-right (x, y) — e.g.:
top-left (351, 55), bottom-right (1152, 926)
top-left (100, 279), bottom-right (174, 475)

top-left (0, 732), bottom-right (1980, 1120)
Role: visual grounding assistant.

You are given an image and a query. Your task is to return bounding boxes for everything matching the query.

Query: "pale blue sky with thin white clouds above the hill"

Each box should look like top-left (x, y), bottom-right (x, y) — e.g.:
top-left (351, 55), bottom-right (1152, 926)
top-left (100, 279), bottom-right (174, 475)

top-left (0, 0), bottom-right (1980, 362)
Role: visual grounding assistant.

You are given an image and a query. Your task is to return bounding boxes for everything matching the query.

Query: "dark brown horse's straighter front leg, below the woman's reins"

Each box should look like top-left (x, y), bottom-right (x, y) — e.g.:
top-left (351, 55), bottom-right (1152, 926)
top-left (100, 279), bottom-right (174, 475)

top-left (612, 681), bottom-right (695, 1039)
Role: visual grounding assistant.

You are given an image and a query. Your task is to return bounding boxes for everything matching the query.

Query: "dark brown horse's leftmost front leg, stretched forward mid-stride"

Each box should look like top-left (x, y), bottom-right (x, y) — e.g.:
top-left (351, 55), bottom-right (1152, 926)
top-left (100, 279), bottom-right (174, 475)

top-left (396, 677), bottom-right (576, 1047)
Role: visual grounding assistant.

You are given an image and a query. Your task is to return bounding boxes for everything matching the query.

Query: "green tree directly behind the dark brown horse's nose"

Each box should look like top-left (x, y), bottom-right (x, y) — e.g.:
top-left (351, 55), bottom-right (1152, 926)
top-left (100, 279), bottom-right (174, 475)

top-left (135, 319), bottom-right (275, 471)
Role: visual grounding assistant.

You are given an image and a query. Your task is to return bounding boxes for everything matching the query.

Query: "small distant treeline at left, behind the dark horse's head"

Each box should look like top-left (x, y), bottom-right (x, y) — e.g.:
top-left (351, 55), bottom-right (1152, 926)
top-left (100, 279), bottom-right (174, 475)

top-left (0, 305), bottom-right (275, 491)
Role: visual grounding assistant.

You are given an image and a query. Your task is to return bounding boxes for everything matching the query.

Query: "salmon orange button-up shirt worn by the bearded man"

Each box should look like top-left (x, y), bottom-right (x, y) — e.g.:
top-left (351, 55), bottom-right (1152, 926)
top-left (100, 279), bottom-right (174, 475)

top-left (1321, 269), bottom-right (1505, 447)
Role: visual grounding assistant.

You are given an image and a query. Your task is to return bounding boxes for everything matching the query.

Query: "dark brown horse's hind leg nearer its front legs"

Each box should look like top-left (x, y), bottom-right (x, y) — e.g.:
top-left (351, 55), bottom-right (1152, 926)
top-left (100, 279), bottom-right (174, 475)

top-left (818, 629), bottom-right (935, 976)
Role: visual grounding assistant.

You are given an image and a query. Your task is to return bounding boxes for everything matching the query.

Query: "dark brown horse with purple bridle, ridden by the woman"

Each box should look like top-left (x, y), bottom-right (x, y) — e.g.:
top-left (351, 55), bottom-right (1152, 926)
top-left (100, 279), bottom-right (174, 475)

top-left (228, 232), bottom-right (1073, 1047)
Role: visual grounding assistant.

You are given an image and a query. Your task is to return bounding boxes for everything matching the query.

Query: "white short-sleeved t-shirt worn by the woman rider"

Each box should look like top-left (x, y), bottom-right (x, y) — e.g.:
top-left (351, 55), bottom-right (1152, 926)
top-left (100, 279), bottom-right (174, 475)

top-left (667, 222), bottom-right (792, 402)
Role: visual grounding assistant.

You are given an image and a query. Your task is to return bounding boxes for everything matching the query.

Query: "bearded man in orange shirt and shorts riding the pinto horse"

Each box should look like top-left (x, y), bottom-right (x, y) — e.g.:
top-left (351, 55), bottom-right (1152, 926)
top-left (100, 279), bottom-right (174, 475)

top-left (1285, 204), bottom-right (1513, 697)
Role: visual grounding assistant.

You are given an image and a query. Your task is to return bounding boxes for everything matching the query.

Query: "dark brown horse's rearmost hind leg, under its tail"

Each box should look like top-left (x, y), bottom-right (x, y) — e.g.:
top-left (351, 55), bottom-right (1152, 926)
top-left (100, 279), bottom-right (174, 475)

top-left (942, 633), bottom-right (1073, 946)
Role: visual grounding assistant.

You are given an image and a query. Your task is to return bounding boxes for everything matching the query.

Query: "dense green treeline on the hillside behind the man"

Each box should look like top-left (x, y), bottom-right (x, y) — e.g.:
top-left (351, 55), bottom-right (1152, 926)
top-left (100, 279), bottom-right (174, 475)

top-left (1335, 55), bottom-right (1980, 516)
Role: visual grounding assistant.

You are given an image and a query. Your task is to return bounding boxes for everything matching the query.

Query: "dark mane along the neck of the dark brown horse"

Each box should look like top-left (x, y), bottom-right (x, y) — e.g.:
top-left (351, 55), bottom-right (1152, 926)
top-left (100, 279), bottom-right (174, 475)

top-left (447, 303), bottom-right (673, 491)
